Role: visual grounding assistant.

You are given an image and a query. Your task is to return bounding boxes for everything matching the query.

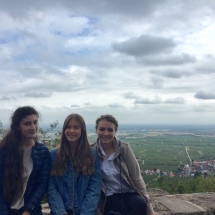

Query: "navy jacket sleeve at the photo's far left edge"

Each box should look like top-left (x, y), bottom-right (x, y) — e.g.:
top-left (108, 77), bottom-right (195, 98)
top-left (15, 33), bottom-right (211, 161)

top-left (0, 150), bottom-right (8, 215)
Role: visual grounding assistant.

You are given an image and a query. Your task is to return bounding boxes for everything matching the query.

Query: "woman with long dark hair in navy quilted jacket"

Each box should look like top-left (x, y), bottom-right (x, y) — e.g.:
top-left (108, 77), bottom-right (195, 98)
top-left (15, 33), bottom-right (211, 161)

top-left (0, 106), bottom-right (50, 215)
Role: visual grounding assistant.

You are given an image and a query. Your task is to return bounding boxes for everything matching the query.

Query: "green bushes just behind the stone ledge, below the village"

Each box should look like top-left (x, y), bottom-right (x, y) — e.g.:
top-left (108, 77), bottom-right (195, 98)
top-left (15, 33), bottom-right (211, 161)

top-left (148, 176), bottom-right (215, 194)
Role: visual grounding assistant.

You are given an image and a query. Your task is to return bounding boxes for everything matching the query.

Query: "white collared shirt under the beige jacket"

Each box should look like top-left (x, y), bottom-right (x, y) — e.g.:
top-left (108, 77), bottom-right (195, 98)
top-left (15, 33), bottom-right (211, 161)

top-left (98, 142), bottom-right (134, 196)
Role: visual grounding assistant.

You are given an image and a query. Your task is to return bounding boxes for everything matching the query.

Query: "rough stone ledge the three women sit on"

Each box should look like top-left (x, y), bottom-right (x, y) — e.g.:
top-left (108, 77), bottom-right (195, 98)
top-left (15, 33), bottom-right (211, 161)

top-left (42, 189), bottom-right (215, 215)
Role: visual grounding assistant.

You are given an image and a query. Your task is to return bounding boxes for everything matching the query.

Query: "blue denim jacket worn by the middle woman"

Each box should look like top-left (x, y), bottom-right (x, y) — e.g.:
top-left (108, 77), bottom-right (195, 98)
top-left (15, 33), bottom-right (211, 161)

top-left (47, 148), bottom-right (102, 215)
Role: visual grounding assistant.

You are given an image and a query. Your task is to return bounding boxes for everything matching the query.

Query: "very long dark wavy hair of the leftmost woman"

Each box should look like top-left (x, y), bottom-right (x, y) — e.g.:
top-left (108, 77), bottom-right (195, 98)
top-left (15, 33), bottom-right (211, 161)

top-left (0, 106), bottom-right (39, 203)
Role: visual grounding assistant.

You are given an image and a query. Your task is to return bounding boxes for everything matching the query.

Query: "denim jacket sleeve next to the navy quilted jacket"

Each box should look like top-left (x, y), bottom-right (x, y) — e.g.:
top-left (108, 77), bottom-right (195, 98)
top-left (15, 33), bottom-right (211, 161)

top-left (47, 149), bottom-right (67, 215)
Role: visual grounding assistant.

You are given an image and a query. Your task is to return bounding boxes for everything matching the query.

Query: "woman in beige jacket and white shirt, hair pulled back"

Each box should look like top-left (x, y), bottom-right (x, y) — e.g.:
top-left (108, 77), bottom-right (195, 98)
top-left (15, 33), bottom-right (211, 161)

top-left (92, 115), bottom-right (156, 215)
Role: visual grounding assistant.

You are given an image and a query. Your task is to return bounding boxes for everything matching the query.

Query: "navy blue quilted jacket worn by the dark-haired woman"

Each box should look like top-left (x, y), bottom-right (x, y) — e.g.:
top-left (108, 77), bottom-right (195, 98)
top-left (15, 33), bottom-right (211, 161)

top-left (0, 142), bottom-right (51, 215)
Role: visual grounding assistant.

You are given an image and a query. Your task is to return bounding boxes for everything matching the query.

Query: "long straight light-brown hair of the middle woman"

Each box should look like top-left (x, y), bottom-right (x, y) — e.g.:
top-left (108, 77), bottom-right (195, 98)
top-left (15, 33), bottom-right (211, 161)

top-left (51, 113), bottom-right (94, 176)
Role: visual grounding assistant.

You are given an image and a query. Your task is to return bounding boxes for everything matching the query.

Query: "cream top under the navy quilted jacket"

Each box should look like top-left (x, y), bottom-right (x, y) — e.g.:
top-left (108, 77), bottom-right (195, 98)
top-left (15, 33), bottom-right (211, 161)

top-left (10, 147), bottom-right (33, 210)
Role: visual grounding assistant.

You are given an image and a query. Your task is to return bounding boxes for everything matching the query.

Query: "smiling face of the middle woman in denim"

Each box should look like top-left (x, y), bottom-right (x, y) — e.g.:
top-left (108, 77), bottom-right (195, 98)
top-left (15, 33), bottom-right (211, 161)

top-left (64, 119), bottom-right (81, 144)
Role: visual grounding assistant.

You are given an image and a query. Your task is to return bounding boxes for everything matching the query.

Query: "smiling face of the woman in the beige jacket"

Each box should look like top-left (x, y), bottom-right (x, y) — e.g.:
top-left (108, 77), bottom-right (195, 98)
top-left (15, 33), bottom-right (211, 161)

top-left (96, 120), bottom-right (116, 145)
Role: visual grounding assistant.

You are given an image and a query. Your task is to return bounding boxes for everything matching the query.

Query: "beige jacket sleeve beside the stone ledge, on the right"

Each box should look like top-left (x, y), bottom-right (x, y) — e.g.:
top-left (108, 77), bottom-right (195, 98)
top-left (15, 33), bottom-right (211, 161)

top-left (122, 144), bottom-right (154, 214)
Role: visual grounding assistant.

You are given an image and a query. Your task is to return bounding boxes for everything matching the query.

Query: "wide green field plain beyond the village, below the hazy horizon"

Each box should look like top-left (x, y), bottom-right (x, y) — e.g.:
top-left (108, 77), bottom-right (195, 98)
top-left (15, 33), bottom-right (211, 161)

top-left (89, 132), bottom-right (215, 172)
